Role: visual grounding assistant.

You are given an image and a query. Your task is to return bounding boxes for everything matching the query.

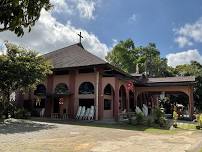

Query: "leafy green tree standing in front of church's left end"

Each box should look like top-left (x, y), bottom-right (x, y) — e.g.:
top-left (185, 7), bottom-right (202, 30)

top-left (0, 44), bottom-right (52, 117)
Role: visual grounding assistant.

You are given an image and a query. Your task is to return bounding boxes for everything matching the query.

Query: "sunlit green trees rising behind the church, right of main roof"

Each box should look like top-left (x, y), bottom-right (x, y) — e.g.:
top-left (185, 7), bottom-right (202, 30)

top-left (106, 39), bottom-right (172, 77)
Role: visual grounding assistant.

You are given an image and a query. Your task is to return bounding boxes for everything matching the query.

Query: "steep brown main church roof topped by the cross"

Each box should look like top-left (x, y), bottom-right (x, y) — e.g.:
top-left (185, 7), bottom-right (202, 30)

top-left (44, 43), bottom-right (107, 69)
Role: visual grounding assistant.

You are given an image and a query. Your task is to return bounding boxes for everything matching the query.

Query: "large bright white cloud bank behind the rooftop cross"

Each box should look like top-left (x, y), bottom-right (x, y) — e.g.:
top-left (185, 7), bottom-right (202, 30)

top-left (0, 10), bottom-right (109, 58)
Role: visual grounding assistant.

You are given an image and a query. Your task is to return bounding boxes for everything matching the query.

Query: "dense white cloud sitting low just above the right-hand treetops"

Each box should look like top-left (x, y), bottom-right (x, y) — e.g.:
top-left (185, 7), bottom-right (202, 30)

top-left (166, 49), bottom-right (202, 67)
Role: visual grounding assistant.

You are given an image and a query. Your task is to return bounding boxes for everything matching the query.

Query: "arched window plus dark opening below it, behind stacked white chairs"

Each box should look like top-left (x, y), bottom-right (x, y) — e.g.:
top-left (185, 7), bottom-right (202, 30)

top-left (78, 82), bottom-right (95, 108)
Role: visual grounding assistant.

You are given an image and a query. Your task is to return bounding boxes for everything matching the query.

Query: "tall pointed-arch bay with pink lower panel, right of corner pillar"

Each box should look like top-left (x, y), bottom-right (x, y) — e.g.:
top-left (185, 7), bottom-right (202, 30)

top-left (104, 84), bottom-right (114, 119)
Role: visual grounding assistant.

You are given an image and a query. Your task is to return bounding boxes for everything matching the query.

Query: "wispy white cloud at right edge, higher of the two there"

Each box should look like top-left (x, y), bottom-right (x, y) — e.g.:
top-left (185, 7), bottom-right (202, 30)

top-left (174, 17), bottom-right (202, 47)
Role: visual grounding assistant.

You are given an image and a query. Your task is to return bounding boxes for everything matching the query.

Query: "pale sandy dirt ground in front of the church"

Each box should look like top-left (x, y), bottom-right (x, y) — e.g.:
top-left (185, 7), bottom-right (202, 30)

top-left (0, 120), bottom-right (202, 152)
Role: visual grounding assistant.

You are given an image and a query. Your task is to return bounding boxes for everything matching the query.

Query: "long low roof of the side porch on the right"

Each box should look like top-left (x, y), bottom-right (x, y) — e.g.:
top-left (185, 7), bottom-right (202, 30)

top-left (147, 76), bottom-right (195, 83)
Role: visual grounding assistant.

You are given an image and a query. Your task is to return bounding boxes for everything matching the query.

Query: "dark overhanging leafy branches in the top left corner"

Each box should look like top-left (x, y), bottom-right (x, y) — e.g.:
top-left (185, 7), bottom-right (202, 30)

top-left (0, 0), bottom-right (52, 36)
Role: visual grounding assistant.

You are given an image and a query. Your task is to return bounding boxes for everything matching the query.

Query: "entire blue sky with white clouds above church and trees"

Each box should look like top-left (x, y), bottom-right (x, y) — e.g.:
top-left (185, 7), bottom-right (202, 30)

top-left (0, 0), bottom-right (202, 66)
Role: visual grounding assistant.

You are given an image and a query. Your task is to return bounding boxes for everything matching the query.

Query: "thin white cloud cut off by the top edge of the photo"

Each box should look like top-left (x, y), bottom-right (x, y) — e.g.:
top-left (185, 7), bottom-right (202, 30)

top-left (51, 0), bottom-right (99, 20)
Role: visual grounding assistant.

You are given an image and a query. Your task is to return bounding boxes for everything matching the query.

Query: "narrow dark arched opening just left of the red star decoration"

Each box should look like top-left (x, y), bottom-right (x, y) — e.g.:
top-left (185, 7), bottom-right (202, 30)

top-left (119, 85), bottom-right (127, 112)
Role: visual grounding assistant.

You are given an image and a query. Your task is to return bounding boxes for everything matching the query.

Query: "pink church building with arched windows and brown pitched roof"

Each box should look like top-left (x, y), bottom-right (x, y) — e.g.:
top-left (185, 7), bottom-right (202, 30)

top-left (17, 43), bottom-right (195, 120)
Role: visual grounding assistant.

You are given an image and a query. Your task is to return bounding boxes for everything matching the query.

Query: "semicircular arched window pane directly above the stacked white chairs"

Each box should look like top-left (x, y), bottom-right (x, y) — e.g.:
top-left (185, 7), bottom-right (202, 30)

top-left (79, 82), bottom-right (94, 94)
